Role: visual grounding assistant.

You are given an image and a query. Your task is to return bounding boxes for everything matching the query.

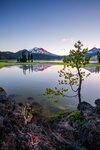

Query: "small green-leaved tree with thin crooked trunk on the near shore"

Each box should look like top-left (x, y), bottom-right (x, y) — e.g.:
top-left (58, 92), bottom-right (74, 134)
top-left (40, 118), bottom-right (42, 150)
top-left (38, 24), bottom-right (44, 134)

top-left (45, 41), bottom-right (90, 113)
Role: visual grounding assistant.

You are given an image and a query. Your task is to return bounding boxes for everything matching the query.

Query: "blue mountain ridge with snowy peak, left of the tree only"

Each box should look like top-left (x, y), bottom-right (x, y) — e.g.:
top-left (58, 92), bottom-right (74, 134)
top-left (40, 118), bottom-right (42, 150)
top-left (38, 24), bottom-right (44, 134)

top-left (0, 47), bottom-right (63, 60)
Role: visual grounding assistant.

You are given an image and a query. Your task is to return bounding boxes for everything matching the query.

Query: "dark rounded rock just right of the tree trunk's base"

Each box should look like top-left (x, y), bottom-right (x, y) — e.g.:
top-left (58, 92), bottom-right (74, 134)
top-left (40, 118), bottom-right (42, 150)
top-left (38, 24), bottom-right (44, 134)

top-left (77, 101), bottom-right (94, 111)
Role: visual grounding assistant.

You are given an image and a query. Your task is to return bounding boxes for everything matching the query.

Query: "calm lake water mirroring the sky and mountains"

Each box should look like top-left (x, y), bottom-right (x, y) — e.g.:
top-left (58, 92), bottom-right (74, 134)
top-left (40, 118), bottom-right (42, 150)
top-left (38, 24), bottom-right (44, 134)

top-left (0, 64), bottom-right (100, 115)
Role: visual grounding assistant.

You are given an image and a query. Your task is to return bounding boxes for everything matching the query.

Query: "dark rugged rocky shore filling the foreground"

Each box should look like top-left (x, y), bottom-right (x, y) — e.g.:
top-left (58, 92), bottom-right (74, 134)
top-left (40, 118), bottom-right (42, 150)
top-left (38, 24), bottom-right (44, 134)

top-left (0, 88), bottom-right (100, 150)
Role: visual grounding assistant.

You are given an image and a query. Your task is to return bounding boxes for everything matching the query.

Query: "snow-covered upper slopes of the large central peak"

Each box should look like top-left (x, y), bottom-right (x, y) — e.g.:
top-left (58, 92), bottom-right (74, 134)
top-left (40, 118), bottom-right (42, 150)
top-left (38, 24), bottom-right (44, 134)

top-left (29, 47), bottom-right (56, 56)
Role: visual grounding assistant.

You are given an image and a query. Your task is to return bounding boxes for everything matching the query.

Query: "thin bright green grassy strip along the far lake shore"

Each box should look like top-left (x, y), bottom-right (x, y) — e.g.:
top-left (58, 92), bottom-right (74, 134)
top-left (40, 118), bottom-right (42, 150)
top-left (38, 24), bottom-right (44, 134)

top-left (0, 61), bottom-right (100, 68)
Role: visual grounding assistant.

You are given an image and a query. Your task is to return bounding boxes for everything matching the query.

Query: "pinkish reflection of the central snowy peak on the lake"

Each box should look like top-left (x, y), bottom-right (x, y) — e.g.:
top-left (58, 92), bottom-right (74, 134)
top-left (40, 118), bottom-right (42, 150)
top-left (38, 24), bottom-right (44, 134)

top-left (19, 64), bottom-right (52, 75)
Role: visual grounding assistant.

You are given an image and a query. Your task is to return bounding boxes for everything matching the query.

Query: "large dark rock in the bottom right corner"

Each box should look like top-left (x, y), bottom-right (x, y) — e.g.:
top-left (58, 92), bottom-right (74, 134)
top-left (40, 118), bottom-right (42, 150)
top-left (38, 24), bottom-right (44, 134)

top-left (78, 120), bottom-right (100, 150)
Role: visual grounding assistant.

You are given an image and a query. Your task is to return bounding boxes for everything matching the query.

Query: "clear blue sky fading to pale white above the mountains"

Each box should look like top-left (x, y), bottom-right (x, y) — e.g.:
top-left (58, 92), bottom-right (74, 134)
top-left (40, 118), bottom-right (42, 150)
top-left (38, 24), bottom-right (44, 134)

top-left (0, 0), bottom-right (100, 54)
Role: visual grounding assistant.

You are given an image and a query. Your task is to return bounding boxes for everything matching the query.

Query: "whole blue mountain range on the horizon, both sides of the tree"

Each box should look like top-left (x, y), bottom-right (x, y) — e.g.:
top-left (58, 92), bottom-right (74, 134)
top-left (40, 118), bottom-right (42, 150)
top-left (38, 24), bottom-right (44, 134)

top-left (0, 47), bottom-right (100, 60)
